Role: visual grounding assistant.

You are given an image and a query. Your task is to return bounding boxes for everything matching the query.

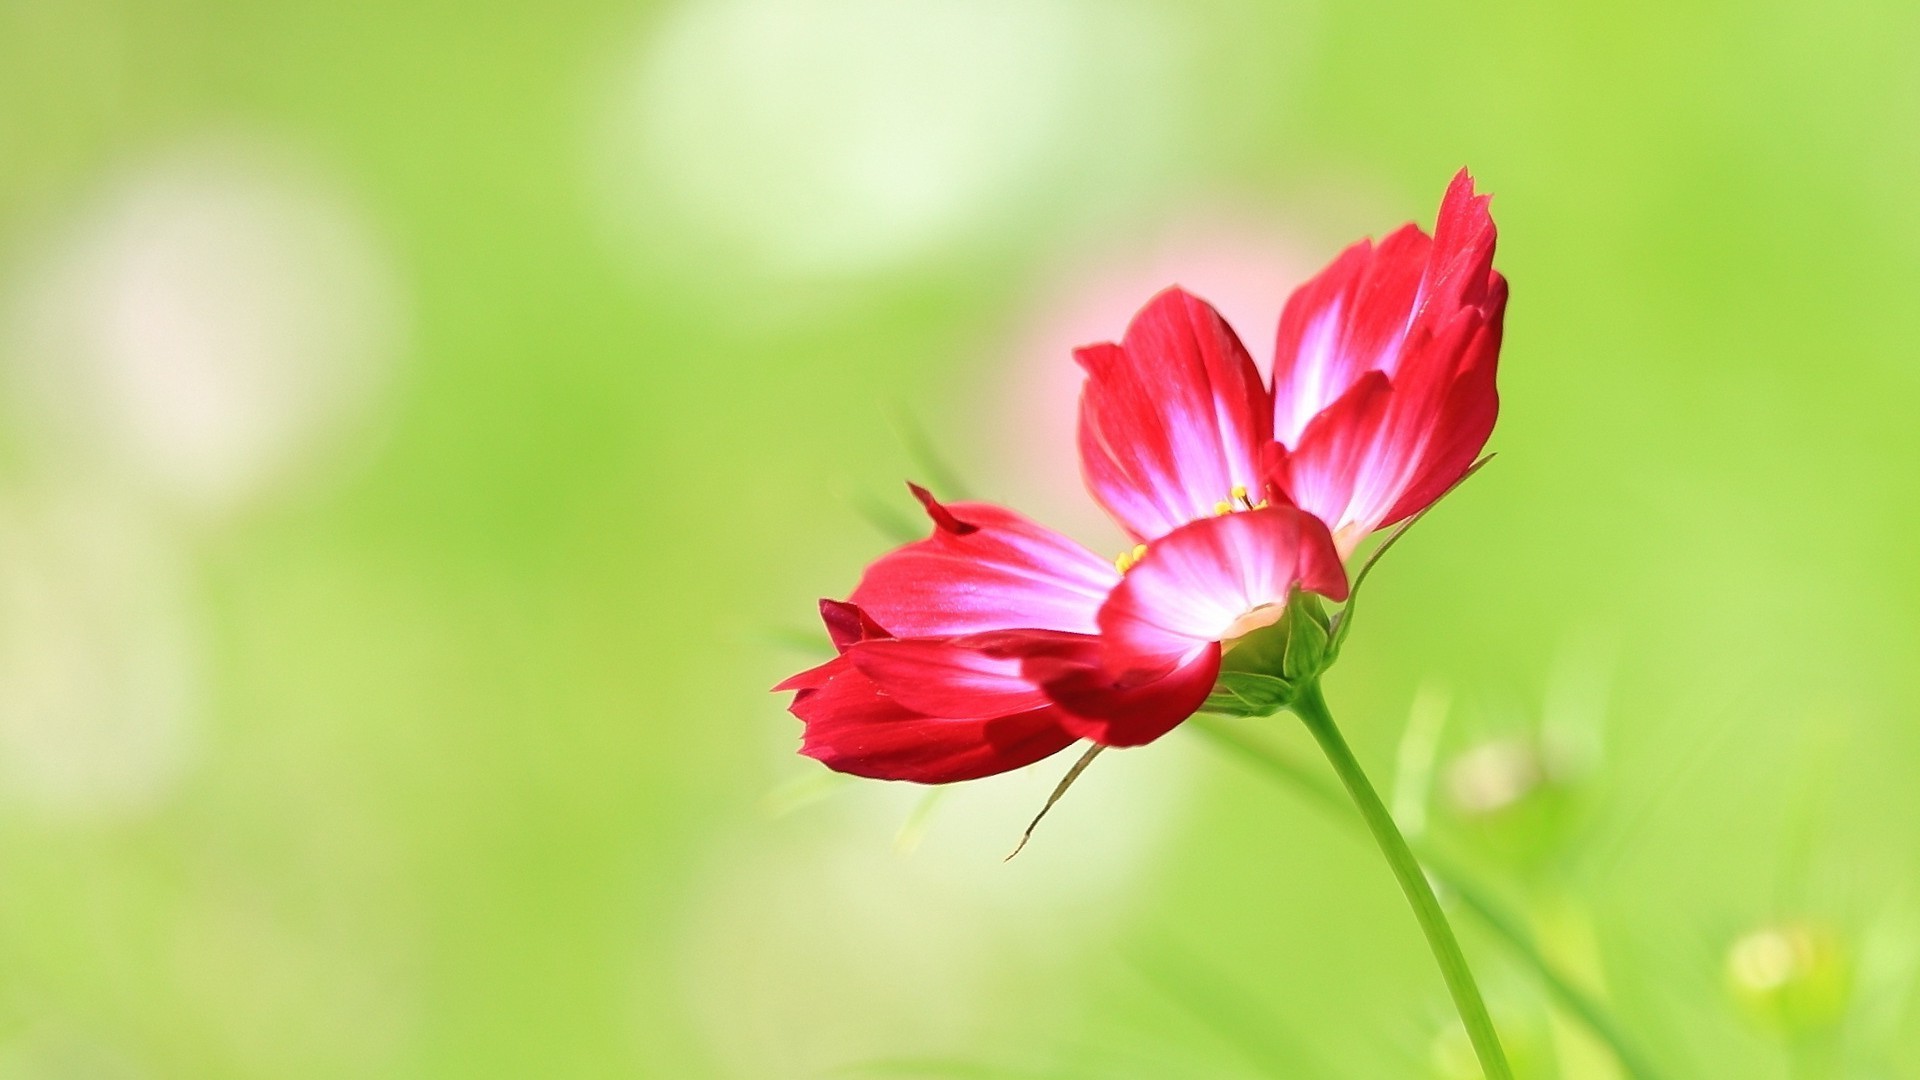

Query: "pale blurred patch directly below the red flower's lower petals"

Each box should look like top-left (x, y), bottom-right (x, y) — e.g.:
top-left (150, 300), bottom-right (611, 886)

top-left (680, 738), bottom-right (1194, 1076)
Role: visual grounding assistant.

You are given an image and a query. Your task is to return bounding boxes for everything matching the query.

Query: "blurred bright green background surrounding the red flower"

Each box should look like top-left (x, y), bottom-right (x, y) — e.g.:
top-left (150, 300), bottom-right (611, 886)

top-left (0, 0), bottom-right (1920, 1078)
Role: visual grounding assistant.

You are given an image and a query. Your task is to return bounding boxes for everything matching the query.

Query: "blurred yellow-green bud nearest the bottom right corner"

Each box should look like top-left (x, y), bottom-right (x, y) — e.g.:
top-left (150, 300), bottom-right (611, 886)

top-left (1726, 922), bottom-right (1853, 1036)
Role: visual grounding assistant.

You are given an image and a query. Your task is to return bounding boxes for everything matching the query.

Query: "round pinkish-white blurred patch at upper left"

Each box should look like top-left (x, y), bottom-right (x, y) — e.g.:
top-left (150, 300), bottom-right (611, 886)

top-left (4, 138), bottom-right (401, 511)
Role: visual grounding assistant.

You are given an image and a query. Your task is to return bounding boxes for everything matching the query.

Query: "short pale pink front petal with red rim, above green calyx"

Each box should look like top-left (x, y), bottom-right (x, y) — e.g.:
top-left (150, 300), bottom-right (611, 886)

top-left (1100, 505), bottom-right (1348, 671)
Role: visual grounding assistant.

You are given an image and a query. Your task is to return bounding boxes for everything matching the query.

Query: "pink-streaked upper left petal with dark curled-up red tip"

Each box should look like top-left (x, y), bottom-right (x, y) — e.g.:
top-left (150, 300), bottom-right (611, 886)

top-left (851, 488), bottom-right (1119, 638)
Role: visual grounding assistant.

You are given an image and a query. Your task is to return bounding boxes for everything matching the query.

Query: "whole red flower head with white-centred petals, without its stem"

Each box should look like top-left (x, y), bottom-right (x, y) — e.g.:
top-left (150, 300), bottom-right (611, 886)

top-left (776, 173), bottom-right (1505, 784)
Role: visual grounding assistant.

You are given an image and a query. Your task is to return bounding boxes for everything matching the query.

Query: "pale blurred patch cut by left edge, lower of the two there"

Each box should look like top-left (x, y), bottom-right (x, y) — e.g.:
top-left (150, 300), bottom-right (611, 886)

top-left (0, 492), bottom-right (202, 821)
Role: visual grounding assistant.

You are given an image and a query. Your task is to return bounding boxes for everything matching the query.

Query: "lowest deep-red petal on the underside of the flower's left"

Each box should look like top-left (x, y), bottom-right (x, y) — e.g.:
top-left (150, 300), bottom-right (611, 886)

top-left (791, 665), bottom-right (1077, 784)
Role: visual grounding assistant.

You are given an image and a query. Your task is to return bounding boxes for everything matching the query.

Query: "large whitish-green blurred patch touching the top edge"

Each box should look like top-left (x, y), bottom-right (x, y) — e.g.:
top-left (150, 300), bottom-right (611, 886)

top-left (595, 0), bottom-right (1183, 277)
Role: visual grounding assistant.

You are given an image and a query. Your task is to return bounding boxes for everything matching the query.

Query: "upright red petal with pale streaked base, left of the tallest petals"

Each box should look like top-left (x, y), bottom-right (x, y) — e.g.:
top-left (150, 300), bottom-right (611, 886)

top-left (1075, 288), bottom-right (1273, 540)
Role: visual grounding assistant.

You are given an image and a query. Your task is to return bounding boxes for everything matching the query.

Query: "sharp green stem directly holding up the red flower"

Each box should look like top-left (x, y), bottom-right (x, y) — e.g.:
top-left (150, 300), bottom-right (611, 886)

top-left (1292, 682), bottom-right (1513, 1080)
